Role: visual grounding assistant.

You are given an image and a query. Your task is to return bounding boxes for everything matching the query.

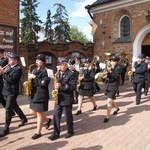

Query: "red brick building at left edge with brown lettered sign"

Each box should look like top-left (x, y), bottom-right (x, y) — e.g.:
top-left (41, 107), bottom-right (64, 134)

top-left (0, 0), bottom-right (19, 54)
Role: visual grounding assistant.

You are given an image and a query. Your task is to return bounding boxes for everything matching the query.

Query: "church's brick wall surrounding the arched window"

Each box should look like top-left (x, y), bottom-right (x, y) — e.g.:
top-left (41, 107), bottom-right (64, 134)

top-left (94, 2), bottom-right (150, 62)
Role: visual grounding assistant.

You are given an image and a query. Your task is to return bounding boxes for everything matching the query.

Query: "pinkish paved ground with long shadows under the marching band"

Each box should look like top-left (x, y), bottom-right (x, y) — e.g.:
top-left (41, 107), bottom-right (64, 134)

top-left (0, 81), bottom-right (150, 150)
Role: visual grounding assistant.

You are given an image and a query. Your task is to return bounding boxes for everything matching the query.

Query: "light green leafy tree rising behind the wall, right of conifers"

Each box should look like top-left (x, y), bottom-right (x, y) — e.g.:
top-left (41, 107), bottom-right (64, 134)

top-left (69, 26), bottom-right (89, 43)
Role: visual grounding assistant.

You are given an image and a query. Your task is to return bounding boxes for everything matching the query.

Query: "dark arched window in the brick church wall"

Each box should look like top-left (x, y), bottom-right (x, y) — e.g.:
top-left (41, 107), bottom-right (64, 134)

top-left (120, 16), bottom-right (130, 38)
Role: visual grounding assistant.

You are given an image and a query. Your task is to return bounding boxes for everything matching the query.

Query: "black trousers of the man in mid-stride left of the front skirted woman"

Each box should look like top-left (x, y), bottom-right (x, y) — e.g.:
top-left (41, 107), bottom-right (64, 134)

top-left (4, 96), bottom-right (26, 131)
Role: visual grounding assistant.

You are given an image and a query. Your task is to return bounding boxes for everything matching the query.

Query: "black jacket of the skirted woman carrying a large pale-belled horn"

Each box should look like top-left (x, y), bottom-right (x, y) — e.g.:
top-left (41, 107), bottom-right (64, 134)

top-left (105, 65), bottom-right (121, 91)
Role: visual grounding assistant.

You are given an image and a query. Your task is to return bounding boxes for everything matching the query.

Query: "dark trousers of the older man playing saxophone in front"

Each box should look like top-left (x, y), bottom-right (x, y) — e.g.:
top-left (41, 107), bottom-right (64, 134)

top-left (53, 105), bottom-right (74, 136)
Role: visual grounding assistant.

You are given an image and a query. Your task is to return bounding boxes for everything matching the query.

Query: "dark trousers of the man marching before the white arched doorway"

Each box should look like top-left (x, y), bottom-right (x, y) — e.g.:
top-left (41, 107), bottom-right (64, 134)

top-left (133, 83), bottom-right (144, 103)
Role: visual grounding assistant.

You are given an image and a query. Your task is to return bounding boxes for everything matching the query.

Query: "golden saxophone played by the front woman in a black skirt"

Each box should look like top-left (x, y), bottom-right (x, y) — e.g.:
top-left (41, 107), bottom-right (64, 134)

top-left (23, 64), bottom-right (35, 96)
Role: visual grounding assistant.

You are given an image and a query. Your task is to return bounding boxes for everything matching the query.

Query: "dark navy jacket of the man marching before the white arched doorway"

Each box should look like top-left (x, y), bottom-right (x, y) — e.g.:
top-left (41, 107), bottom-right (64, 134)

top-left (133, 61), bottom-right (147, 83)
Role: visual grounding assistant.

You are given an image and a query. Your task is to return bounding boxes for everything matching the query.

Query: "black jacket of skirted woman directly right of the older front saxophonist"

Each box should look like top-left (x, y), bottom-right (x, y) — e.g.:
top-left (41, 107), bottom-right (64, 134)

top-left (80, 68), bottom-right (95, 90)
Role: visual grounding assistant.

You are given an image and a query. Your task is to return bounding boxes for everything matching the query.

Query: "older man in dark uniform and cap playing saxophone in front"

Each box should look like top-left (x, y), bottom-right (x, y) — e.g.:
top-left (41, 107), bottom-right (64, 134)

top-left (48, 58), bottom-right (77, 141)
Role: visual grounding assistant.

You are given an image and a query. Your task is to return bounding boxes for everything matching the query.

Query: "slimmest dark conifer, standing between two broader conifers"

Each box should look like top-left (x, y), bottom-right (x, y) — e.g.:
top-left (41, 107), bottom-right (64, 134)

top-left (44, 10), bottom-right (53, 43)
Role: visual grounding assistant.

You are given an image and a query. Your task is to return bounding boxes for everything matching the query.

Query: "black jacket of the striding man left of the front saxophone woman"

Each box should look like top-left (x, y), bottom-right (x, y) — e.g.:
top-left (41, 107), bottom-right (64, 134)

top-left (2, 65), bottom-right (22, 96)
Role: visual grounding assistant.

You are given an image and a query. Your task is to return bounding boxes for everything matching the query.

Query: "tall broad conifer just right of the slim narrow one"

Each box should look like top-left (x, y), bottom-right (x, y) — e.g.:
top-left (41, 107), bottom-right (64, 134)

top-left (52, 3), bottom-right (70, 43)
